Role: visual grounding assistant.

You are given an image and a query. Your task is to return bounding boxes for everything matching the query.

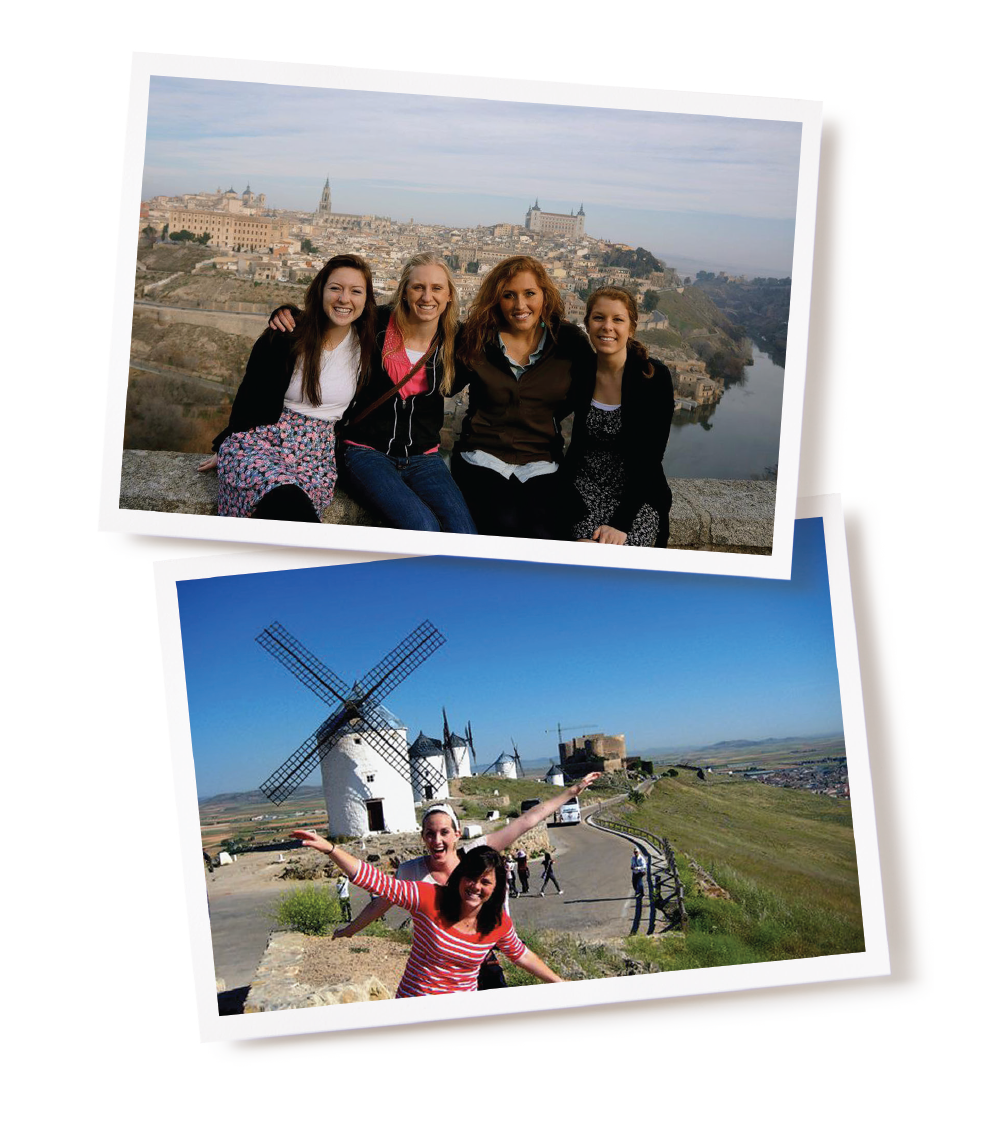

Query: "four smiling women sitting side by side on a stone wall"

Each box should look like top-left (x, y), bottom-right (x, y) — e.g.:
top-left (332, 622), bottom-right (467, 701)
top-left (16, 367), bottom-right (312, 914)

top-left (199, 252), bottom-right (673, 546)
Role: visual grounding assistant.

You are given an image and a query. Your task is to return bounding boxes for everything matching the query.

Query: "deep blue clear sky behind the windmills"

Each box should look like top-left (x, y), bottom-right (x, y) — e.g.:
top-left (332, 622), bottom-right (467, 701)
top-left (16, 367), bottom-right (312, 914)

top-left (178, 519), bottom-right (841, 797)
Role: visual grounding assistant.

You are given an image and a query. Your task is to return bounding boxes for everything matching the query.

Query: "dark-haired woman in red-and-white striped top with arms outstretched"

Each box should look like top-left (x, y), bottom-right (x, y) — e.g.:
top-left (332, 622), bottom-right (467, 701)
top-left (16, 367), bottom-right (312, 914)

top-left (291, 829), bottom-right (563, 998)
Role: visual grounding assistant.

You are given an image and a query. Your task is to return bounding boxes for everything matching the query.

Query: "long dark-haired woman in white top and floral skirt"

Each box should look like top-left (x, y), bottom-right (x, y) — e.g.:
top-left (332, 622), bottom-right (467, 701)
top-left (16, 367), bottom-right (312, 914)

top-left (198, 254), bottom-right (376, 523)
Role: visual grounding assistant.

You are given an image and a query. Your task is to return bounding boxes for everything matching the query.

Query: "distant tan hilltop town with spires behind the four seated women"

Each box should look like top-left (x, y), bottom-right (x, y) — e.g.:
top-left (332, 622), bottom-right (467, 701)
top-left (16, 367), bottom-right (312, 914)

top-left (138, 179), bottom-right (788, 413)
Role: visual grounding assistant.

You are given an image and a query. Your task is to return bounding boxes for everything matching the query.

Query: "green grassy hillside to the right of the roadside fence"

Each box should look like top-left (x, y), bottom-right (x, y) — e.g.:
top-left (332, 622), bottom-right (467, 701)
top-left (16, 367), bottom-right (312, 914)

top-left (612, 770), bottom-right (864, 969)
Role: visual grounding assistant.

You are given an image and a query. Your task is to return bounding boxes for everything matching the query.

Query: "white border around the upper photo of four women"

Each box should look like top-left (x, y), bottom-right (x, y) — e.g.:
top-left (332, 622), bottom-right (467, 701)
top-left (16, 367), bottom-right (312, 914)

top-left (100, 52), bottom-right (823, 579)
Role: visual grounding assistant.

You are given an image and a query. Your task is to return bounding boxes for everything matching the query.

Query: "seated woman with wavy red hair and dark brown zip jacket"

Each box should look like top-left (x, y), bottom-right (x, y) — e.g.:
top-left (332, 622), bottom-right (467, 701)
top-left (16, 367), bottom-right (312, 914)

top-left (451, 256), bottom-right (593, 538)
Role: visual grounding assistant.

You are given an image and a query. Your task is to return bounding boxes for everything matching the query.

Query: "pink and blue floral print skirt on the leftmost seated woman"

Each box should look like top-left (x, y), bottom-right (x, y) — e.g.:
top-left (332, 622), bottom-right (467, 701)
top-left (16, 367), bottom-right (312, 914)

top-left (218, 408), bottom-right (338, 518)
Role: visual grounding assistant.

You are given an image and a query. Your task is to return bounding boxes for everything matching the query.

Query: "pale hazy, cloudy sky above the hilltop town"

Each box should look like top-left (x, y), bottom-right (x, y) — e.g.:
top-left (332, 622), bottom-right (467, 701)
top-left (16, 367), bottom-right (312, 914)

top-left (143, 77), bottom-right (801, 276)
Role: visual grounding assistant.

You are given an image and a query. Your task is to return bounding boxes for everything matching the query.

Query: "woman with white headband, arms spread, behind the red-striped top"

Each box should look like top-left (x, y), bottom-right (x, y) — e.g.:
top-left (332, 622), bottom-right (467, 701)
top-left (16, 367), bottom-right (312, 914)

top-left (333, 774), bottom-right (602, 939)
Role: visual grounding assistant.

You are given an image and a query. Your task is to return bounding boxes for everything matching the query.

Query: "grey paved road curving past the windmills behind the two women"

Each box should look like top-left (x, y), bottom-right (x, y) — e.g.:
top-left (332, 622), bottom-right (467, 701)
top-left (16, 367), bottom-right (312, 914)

top-left (207, 796), bottom-right (651, 992)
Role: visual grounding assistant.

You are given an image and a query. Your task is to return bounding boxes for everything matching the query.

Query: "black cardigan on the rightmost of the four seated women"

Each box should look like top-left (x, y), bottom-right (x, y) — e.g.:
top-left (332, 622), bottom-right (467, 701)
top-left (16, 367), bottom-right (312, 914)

top-left (563, 352), bottom-right (673, 546)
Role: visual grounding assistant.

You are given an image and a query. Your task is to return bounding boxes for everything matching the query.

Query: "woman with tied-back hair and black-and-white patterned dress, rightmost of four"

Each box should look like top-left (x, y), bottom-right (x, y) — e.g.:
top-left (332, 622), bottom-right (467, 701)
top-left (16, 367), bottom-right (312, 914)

top-left (564, 287), bottom-right (673, 546)
